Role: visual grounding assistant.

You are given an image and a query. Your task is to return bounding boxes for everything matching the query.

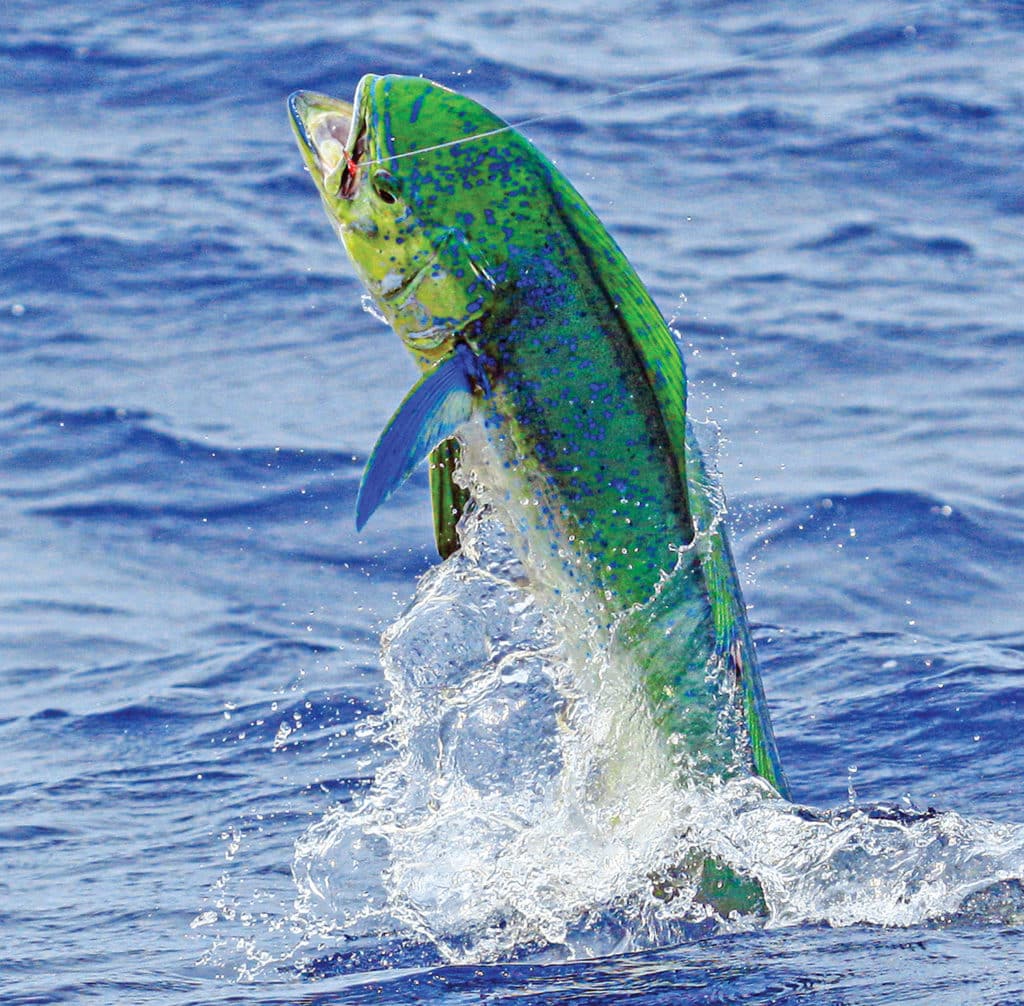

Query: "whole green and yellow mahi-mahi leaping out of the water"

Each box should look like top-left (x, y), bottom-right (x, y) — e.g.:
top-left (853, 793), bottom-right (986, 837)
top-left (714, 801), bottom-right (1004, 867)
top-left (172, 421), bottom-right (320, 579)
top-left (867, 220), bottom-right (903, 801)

top-left (289, 75), bottom-right (788, 905)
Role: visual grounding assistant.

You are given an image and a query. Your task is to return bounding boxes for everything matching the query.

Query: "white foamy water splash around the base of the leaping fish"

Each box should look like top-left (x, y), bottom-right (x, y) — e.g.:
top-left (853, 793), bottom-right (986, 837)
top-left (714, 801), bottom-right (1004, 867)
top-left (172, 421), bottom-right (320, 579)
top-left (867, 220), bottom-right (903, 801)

top-left (293, 499), bottom-right (1024, 962)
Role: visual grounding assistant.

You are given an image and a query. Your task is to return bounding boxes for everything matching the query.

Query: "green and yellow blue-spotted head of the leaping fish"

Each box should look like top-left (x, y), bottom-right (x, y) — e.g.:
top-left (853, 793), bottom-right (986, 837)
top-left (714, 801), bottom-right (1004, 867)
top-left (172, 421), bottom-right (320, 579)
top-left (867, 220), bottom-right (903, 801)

top-left (289, 75), bottom-right (536, 368)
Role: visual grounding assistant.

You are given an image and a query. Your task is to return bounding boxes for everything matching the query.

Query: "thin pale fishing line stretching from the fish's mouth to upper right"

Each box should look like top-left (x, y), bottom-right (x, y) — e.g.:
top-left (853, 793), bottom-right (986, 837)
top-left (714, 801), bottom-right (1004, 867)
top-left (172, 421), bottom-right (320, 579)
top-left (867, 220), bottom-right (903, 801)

top-left (359, 3), bottom-right (928, 167)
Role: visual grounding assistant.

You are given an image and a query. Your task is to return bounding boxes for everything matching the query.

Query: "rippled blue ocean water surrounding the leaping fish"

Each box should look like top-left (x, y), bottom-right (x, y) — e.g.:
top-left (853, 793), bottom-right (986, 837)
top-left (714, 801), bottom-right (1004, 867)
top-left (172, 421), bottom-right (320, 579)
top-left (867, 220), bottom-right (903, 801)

top-left (0, 0), bottom-right (1024, 1004)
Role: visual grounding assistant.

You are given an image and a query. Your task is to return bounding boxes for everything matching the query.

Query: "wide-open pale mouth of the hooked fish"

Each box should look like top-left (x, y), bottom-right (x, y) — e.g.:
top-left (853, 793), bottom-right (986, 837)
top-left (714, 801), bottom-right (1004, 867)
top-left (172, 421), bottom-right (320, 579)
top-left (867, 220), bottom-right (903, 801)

top-left (288, 91), bottom-right (367, 199)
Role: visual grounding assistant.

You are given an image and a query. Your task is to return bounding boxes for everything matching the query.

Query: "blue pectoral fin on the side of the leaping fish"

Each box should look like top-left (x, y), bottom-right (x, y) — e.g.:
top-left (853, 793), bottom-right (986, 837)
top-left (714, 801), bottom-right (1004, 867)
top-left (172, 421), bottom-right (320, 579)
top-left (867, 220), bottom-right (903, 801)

top-left (355, 344), bottom-right (486, 531)
